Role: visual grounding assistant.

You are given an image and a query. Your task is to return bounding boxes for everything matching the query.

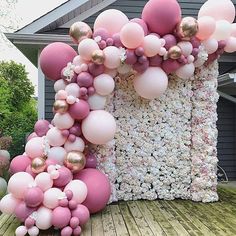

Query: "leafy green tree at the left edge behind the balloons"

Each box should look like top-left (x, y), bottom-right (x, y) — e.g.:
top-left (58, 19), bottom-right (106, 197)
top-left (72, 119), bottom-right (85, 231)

top-left (0, 61), bottom-right (37, 156)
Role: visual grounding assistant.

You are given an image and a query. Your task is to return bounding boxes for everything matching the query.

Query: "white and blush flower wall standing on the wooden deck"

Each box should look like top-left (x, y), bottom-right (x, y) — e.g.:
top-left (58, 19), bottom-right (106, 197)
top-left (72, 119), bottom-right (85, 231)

top-left (93, 59), bottom-right (218, 202)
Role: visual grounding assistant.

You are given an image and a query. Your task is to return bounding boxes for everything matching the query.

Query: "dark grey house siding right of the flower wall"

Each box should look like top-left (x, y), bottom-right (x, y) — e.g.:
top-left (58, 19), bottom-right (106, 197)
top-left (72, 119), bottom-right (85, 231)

top-left (217, 98), bottom-right (236, 180)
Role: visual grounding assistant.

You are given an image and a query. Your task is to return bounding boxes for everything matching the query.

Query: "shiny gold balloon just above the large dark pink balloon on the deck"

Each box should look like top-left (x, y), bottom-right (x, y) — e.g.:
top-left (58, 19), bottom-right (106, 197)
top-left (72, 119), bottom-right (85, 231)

top-left (64, 151), bottom-right (86, 173)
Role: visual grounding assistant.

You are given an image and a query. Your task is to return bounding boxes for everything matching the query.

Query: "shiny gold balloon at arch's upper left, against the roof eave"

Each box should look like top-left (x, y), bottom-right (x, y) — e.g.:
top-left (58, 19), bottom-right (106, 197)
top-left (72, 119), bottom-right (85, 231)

top-left (69, 21), bottom-right (92, 44)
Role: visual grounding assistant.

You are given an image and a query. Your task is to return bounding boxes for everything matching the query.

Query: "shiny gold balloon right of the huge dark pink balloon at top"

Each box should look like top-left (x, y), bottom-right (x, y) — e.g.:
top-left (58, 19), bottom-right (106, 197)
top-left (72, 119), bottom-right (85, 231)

top-left (177, 16), bottom-right (198, 40)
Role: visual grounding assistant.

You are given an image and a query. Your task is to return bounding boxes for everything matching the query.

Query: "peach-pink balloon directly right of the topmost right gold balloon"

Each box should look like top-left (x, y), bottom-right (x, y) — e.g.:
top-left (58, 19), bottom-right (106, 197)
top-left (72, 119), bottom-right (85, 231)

top-left (196, 16), bottom-right (216, 40)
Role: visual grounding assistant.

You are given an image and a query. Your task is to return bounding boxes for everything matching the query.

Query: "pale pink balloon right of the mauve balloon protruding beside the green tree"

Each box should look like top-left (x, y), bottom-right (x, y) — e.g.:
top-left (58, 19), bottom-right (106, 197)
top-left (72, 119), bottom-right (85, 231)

top-left (46, 127), bottom-right (66, 147)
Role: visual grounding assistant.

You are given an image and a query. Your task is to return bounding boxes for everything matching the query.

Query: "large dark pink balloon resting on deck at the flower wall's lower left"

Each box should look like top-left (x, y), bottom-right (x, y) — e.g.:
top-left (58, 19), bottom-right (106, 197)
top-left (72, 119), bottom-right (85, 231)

top-left (75, 168), bottom-right (111, 213)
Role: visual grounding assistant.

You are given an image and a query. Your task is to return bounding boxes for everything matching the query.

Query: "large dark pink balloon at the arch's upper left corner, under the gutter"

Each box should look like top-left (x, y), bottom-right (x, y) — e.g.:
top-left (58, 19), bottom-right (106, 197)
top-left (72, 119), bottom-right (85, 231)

top-left (39, 42), bottom-right (77, 80)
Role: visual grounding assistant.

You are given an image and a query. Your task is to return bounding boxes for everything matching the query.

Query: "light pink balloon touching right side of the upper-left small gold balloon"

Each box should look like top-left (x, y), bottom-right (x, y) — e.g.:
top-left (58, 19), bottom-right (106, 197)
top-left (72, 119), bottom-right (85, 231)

top-left (103, 46), bottom-right (121, 69)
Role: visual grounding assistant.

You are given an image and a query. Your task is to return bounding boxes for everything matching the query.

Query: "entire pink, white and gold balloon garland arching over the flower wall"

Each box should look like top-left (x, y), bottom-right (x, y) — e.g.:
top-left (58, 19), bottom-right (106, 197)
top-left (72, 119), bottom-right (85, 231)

top-left (0, 0), bottom-right (236, 236)
